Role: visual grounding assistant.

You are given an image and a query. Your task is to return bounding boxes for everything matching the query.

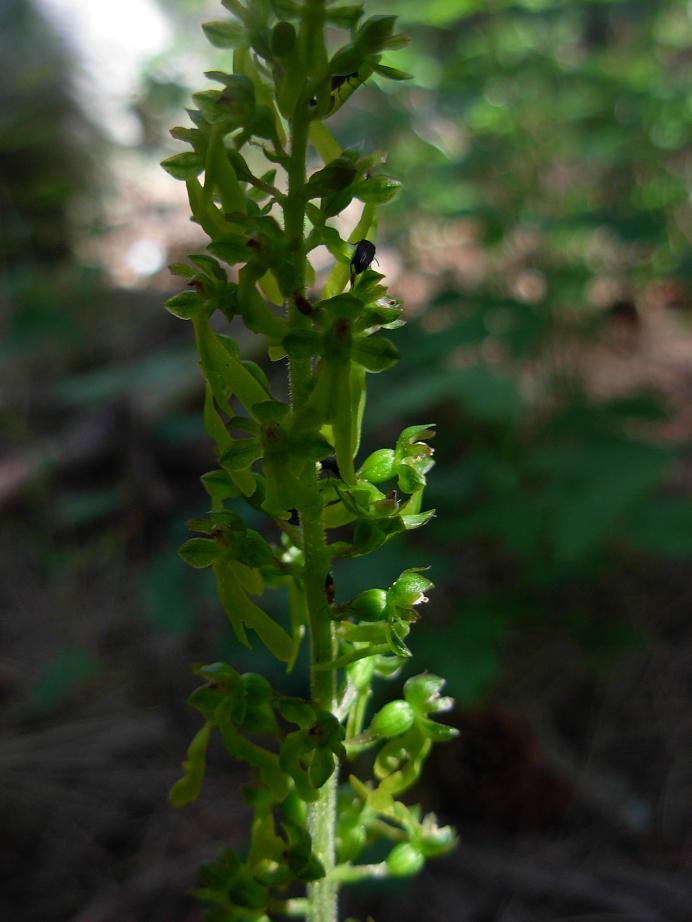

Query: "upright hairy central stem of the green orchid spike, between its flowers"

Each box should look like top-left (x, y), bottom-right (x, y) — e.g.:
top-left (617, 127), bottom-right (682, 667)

top-left (283, 0), bottom-right (338, 922)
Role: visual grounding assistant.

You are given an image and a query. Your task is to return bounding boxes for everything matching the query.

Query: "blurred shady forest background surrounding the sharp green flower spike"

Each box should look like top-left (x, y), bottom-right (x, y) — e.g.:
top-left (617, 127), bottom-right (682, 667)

top-left (0, 0), bottom-right (692, 922)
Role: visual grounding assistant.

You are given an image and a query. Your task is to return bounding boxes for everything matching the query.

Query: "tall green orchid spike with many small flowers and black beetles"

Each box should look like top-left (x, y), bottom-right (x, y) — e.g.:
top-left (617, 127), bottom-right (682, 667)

top-left (163, 0), bottom-right (455, 922)
